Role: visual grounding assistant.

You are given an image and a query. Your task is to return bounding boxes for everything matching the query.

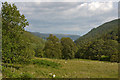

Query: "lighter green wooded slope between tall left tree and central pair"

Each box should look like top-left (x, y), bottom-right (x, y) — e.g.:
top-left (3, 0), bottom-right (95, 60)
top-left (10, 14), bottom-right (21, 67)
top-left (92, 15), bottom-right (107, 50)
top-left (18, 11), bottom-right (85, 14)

top-left (23, 31), bottom-right (45, 57)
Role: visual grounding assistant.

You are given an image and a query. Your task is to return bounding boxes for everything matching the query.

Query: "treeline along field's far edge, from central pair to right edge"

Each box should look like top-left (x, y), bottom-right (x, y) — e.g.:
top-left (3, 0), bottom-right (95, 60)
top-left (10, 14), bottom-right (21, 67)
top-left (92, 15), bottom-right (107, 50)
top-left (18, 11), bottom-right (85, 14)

top-left (37, 31), bottom-right (119, 62)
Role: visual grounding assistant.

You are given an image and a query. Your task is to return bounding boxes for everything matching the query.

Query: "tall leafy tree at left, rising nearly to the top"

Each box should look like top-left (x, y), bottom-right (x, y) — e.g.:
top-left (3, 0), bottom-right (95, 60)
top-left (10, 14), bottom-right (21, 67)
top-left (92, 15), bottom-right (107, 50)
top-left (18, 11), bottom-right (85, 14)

top-left (1, 2), bottom-right (34, 63)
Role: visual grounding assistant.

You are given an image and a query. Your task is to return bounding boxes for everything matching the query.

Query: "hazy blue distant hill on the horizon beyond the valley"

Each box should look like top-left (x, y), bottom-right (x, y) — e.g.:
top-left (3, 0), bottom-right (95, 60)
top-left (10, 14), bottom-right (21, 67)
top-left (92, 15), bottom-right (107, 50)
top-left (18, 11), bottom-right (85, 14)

top-left (31, 32), bottom-right (80, 40)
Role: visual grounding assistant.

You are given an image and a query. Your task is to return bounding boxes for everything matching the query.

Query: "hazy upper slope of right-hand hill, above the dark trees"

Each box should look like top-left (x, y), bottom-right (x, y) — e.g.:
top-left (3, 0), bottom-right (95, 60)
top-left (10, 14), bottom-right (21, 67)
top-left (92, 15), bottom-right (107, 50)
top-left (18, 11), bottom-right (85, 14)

top-left (75, 19), bottom-right (118, 45)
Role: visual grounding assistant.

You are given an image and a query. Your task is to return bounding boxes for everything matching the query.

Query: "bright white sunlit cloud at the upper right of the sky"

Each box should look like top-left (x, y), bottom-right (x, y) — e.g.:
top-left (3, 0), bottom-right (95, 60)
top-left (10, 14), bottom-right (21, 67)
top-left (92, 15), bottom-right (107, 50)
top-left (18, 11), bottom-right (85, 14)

top-left (64, 2), bottom-right (114, 17)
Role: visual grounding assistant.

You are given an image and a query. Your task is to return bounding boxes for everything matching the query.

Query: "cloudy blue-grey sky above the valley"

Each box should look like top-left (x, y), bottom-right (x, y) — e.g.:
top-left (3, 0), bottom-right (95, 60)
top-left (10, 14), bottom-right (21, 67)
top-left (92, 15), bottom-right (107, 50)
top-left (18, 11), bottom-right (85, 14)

top-left (0, 1), bottom-right (118, 36)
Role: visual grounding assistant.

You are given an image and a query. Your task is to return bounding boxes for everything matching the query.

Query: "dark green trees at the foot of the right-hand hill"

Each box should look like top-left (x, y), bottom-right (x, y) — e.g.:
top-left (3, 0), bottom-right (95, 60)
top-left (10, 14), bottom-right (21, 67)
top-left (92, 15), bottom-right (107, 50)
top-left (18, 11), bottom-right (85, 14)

top-left (76, 38), bottom-right (118, 62)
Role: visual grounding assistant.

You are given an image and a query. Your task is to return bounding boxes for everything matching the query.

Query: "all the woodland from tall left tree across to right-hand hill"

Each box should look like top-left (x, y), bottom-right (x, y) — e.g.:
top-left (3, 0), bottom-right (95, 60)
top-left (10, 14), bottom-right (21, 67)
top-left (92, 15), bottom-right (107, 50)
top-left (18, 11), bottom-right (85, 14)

top-left (0, 2), bottom-right (120, 78)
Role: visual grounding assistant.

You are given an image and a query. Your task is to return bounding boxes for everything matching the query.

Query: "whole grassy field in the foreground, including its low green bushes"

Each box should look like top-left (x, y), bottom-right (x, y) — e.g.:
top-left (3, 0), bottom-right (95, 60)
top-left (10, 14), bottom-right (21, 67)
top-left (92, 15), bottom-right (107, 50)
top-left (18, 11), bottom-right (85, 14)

top-left (3, 58), bottom-right (118, 78)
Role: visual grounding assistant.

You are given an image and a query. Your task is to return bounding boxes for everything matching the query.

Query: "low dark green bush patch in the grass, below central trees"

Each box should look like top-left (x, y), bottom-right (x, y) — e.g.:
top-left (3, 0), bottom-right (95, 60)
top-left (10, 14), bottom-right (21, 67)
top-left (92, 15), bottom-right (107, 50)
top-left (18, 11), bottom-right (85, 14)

top-left (32, 59), bottom-right (61, 68)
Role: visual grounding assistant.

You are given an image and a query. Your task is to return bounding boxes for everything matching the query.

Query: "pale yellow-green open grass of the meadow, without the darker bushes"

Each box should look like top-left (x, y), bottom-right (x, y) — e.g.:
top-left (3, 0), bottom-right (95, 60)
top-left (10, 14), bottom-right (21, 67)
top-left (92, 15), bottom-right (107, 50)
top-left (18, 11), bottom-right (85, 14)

top-left (2, 58), bottom-right (118, 78)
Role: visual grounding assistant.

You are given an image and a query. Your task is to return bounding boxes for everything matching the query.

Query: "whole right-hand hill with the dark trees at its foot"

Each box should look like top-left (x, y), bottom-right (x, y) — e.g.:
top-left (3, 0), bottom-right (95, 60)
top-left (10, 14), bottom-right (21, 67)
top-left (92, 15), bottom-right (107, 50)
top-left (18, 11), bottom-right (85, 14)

top-left (76, 20), bottom-right (119, 62)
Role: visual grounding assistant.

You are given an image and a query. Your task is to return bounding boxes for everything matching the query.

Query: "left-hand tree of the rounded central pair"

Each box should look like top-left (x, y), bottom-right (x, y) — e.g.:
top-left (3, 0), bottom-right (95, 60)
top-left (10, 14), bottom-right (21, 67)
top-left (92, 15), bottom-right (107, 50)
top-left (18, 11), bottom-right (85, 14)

top-left (44, 34), bottom-right (61, 58)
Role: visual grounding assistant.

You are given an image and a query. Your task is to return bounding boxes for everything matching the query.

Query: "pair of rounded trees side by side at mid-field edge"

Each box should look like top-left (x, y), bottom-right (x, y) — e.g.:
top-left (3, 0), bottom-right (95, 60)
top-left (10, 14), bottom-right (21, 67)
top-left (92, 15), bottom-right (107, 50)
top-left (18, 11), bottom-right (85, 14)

top-left (36, 34), bottom-right (77, 59)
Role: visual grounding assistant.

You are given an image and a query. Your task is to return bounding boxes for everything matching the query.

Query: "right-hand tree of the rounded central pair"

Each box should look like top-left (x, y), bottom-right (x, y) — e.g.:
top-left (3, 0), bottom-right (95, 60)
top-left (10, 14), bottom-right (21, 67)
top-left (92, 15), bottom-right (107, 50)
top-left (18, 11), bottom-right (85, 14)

top-left (61, 37), bottom-right (77, 59)
